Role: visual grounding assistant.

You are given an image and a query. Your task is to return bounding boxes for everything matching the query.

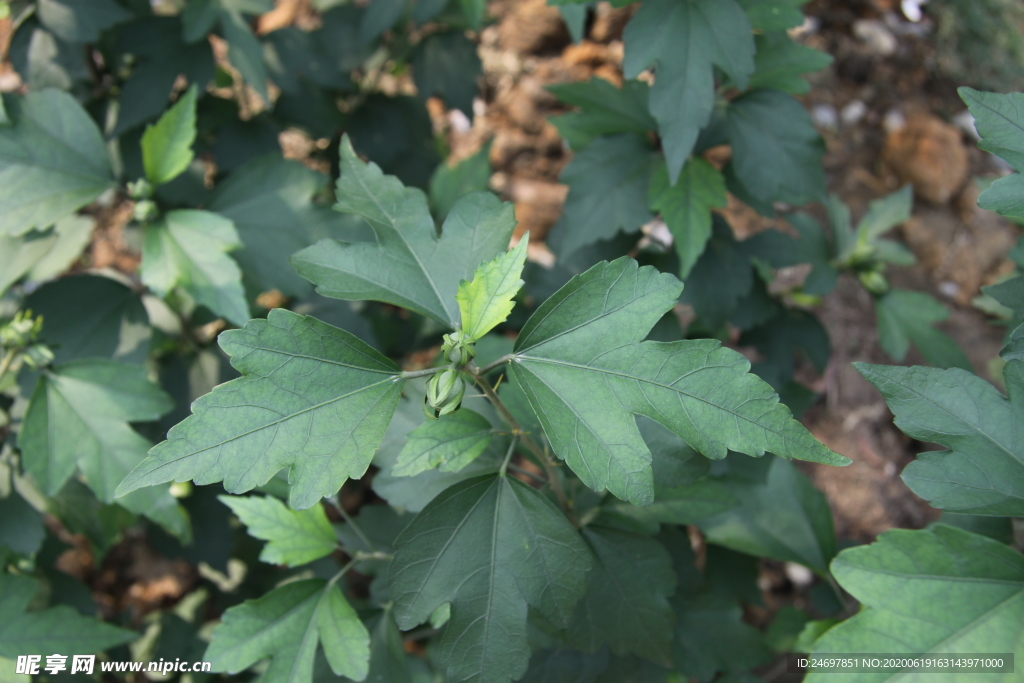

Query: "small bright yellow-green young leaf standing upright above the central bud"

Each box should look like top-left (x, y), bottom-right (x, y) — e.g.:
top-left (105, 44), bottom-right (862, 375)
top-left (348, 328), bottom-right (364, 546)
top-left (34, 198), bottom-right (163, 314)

top-left (455, 232), bottom-right (529, 341)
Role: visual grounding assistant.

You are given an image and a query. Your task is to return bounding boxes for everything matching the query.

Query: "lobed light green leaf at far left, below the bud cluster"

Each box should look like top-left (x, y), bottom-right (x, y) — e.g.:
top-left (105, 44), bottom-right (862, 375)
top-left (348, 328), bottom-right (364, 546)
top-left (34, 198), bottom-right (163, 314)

top-left (18, 359), bottom-right (188, 535)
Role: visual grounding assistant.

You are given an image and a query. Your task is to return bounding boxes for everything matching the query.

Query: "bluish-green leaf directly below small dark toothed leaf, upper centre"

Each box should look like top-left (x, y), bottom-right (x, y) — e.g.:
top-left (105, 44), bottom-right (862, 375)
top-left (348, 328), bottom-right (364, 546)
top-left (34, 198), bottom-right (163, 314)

top-left (549, 134), bottom-right (658, 256)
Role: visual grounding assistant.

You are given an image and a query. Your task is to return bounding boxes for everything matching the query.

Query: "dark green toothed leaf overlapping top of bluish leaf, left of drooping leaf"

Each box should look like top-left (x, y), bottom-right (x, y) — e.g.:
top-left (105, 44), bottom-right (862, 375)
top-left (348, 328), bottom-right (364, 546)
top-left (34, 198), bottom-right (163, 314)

top-left (548, 77), bottom-right (657, 151)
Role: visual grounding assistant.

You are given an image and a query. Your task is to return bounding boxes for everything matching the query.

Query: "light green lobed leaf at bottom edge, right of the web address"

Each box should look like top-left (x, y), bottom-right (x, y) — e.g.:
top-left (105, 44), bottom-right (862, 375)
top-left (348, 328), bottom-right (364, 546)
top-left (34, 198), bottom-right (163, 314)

top-left (203, 579), bottom-right (370, 683)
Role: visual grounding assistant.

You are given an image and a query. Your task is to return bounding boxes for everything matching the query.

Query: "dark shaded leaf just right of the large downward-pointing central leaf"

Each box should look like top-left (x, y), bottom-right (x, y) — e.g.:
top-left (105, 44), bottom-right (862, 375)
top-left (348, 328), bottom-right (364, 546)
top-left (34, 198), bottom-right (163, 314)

top-left (567, 527), bottom-right (676, 667)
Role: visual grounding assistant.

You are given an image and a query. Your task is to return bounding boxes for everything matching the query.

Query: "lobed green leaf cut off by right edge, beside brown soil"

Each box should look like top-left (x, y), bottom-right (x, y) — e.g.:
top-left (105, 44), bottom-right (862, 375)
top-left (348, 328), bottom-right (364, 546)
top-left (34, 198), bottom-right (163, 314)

top-left (957, 87), bottom-right (1024, 218)
